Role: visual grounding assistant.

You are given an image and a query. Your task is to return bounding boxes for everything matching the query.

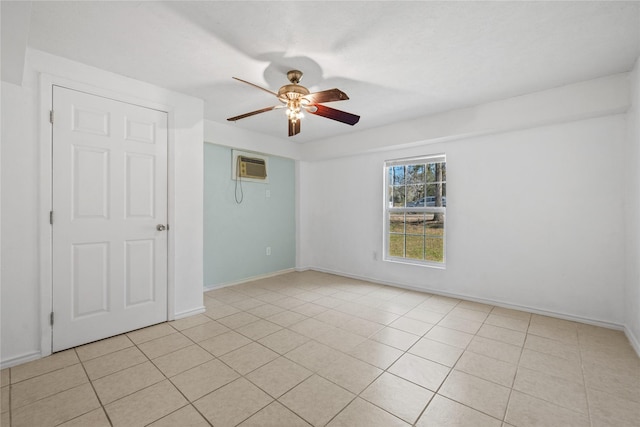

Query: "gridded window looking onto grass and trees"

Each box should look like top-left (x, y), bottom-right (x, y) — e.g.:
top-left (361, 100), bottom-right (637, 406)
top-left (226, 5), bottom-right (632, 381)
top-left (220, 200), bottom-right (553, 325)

top-left (384, 155), bottom-right (447, 266)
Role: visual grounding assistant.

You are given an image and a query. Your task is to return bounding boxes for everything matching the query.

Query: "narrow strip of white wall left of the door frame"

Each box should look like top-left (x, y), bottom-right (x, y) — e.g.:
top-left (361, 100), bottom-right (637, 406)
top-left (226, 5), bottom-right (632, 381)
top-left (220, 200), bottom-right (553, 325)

top-left (0, 82), bottom-right (40, 365)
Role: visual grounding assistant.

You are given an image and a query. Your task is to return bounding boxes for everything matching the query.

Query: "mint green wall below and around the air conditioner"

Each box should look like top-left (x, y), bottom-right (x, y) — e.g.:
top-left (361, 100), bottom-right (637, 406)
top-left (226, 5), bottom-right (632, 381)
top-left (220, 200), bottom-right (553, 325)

top-left (204, 143), bottom-right (296, 287)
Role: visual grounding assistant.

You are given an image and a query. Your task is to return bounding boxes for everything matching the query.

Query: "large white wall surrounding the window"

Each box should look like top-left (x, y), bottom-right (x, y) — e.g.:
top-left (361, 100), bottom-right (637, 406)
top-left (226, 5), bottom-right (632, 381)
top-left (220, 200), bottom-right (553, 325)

top-left (299, 75), bottom-right (628, 327)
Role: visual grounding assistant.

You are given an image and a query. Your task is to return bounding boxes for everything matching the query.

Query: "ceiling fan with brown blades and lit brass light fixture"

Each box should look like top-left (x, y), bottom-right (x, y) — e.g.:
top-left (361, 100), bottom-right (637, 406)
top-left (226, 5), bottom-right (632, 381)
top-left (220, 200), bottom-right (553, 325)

top-left (227, 70), bottom-right (360, 136)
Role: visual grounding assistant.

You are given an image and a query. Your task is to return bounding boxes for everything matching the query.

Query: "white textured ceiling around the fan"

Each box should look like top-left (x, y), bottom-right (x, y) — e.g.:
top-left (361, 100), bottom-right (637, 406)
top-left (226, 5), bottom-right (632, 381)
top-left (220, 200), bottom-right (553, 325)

top-left (18, 1), bottom-right (640, 142)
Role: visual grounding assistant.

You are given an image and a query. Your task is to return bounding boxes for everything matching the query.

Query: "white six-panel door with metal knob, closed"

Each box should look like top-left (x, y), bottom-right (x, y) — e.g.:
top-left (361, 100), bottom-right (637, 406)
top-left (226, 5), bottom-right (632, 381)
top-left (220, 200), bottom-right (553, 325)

top-left (52, 86), bottom-right (168, 351)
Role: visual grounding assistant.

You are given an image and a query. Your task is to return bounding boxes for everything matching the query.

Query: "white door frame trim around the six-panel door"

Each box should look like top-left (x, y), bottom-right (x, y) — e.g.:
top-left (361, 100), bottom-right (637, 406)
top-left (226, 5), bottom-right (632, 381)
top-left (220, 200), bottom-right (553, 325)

top-left (38, 73), bottom-right (175, 357)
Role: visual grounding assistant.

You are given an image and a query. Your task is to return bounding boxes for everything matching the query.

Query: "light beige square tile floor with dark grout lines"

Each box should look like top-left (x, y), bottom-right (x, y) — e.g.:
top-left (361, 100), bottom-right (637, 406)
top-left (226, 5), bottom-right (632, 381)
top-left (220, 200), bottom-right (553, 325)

top-left (1, 271), bottom-right (640, 427)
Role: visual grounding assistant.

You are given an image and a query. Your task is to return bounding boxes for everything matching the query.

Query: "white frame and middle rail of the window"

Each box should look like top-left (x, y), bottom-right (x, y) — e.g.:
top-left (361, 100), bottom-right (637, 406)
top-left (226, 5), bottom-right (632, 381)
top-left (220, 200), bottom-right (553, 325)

top-left (382, 154), bottom-right (447, 269)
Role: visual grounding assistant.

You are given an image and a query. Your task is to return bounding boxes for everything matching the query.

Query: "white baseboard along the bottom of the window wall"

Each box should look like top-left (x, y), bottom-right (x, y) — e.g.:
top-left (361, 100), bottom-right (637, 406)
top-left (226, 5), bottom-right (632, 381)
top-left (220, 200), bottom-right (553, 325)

top-left (306, 267), bottom-right (640, 334)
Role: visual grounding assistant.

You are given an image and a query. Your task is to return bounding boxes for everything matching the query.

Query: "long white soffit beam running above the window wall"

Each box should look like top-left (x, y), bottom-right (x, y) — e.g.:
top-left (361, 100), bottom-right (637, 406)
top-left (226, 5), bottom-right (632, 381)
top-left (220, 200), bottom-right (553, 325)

top-left (301, 73), bottom-right (629, 160)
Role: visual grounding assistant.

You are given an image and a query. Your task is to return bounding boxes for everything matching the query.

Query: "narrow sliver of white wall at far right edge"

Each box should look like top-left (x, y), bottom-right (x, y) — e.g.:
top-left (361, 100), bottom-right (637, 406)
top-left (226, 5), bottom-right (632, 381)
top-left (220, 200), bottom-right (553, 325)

top-left (625, 59), bottom-right (640, 354)
